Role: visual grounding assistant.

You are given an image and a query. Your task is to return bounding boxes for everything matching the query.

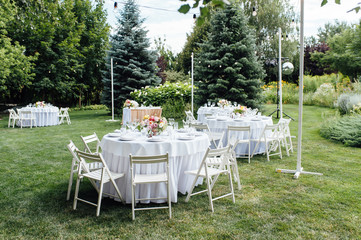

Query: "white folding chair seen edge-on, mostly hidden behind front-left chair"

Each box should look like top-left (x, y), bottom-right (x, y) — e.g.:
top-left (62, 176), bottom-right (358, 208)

top-left (66, 140), bottom-right (103, 200)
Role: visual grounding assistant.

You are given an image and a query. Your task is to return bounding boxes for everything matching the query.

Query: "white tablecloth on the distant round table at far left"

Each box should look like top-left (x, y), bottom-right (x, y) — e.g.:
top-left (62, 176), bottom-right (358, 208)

top-left (16, 106), bottom-right (59, 127)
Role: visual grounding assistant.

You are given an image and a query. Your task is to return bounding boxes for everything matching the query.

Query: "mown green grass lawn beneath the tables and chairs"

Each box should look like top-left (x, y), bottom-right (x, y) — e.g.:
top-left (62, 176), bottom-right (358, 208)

top-left (0, 105), bottom-right (361, 239)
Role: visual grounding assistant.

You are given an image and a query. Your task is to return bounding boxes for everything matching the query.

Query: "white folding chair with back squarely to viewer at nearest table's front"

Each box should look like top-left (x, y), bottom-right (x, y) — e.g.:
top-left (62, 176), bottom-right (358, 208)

top-left (129, 153), bottom-right (172, 220)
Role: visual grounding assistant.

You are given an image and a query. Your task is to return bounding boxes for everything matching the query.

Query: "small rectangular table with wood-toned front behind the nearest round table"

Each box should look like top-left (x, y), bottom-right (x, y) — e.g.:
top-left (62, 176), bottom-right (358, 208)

top-left (122, 107), bottom-right (162, 124)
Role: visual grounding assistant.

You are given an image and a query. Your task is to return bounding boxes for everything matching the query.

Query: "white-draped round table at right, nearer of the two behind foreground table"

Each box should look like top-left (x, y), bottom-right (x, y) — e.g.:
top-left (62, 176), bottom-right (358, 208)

top-left (205, 117), bottom-right (273, 156)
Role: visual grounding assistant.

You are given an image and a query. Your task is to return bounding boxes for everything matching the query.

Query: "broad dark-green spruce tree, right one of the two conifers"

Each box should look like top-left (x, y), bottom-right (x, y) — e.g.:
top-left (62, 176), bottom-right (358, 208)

top-left (194, 6), bottom-right (264, 108)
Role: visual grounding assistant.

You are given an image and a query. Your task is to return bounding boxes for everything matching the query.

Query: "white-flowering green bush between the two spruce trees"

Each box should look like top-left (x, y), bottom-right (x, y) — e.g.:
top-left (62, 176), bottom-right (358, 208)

top-left (130, 82), bottom-right (192, 118)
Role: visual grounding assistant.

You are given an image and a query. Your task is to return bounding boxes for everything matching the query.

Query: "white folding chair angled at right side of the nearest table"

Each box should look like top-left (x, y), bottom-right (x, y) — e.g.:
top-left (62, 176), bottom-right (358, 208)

top-left (184, 146), bottom-right (235, 212)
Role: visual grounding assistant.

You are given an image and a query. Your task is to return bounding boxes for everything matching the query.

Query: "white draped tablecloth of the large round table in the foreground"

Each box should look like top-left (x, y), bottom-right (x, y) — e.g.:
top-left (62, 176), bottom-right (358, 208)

top-left (100, 134), bottom-right (209, 203)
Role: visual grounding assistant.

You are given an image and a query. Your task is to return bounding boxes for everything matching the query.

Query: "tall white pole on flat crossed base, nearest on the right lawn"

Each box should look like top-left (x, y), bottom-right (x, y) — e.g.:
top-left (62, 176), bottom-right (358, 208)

top-left (276, 0), bottom-right (323, 178)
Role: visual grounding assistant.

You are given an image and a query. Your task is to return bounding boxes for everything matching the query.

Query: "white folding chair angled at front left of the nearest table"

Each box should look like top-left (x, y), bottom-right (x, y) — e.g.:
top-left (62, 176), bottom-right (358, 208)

top-left (73, 150), bottom-right (124, 216)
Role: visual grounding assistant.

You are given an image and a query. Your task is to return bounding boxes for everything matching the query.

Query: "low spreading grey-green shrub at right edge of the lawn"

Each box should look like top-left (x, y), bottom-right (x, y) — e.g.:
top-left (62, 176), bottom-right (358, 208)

top-left (320, 115), bottom-right (361, 147)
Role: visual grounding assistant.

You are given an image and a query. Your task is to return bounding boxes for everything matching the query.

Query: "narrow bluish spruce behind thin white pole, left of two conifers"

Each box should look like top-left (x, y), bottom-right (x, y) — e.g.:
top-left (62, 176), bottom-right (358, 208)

top-left (102, 0), bottom-right (160, 113)
